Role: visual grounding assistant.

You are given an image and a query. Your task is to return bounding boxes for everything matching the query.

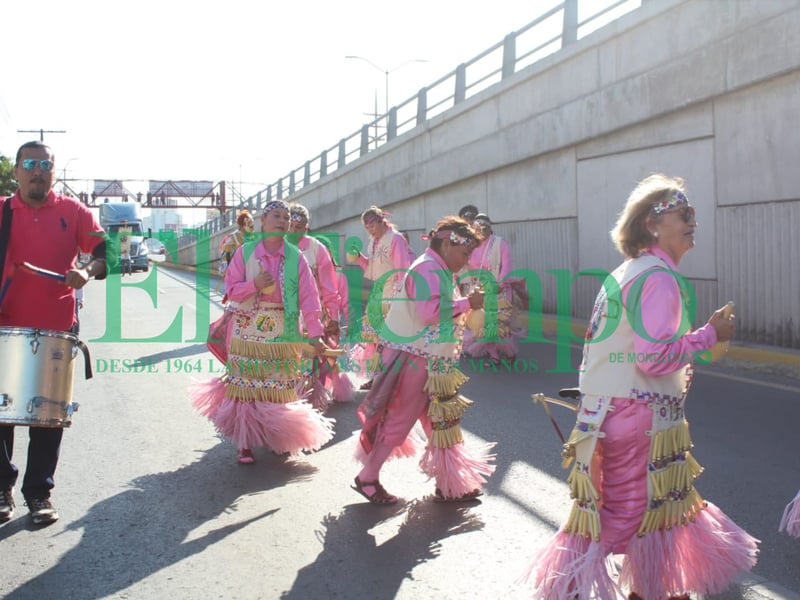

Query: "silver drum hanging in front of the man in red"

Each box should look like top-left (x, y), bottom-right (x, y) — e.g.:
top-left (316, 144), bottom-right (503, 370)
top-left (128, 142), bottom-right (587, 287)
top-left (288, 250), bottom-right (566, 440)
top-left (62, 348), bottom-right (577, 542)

top-left (0, 327), bottom-right (92, 427)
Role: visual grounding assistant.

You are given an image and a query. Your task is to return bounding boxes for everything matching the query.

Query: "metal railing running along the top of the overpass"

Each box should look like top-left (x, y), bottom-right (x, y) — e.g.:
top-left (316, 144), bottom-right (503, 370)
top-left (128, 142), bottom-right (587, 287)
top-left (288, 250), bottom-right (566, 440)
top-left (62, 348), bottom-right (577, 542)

top-left (179, 0), bottom-right (653, 246)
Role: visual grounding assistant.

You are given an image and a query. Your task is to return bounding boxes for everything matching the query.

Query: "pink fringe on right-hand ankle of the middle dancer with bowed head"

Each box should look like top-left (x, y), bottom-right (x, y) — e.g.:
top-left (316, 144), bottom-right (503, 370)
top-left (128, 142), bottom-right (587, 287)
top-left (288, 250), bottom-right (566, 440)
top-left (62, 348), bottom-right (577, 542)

top-left (419, 442), bottom-right (495, 498)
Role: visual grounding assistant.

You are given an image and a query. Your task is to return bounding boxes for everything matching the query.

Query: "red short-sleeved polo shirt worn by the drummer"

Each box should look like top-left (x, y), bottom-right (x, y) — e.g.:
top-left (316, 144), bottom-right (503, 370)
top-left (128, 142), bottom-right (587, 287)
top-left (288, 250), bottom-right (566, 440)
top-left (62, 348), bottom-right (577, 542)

top-left (0, 190), bottom-right (103, 331)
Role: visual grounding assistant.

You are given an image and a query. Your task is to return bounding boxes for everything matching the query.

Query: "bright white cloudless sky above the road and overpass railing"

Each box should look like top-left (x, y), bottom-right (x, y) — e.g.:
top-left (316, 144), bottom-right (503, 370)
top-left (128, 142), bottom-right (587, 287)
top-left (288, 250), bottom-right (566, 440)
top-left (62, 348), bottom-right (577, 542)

top-left (0, 0), bottom-right (624, 211)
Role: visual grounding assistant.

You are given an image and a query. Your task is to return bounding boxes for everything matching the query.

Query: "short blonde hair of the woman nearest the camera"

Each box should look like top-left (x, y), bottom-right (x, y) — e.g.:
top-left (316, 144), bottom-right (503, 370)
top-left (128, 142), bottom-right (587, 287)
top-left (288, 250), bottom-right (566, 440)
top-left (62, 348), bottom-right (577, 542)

top-left (611, 173), bottom-right (686, 258)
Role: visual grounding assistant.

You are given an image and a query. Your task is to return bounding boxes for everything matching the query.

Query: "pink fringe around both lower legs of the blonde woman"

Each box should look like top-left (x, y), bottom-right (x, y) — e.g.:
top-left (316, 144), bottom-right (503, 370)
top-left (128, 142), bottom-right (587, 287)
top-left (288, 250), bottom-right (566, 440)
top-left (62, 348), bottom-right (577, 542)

top-left (521, 502), bottom-right (758, 600)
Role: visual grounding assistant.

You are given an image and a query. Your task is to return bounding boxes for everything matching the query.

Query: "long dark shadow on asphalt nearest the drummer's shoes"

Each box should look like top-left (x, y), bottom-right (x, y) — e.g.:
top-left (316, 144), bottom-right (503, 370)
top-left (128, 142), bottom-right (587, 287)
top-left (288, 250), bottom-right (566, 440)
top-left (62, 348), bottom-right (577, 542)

top-left (2, 443), bottom-right (316, 600)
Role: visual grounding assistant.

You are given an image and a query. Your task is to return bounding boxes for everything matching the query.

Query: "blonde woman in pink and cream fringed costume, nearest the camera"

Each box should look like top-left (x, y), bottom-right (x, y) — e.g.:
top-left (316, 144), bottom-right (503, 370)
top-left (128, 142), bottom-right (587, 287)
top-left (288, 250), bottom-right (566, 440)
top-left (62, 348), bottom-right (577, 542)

top-left (524, 174), bottom-right (758, 600)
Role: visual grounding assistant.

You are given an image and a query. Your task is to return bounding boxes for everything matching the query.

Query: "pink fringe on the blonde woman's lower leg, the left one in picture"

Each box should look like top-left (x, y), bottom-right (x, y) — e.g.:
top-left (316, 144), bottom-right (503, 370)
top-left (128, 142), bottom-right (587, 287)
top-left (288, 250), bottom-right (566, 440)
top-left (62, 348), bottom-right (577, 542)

top-left (517, 531), bottom-right (620, 600)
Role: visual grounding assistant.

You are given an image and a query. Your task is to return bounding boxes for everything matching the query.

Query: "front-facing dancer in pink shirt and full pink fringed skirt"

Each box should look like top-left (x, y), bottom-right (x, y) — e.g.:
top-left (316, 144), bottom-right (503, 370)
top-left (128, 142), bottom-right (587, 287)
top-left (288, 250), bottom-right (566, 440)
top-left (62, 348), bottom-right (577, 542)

top-left (192, 200), bottom-right (333, 464)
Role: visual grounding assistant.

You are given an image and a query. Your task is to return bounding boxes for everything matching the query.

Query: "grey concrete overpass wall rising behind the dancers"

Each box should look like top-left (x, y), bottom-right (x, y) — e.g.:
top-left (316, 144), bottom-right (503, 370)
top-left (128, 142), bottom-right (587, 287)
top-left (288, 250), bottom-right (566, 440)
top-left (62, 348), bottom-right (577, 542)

top-left (175, 0), bottom-right (800, 349)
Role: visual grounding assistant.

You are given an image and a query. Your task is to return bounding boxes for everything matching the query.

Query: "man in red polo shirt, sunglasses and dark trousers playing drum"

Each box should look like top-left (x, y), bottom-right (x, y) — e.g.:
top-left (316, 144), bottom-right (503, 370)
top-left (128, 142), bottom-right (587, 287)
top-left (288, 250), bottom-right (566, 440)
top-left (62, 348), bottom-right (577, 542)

top-left (0, 141), bottom-right (106, 524)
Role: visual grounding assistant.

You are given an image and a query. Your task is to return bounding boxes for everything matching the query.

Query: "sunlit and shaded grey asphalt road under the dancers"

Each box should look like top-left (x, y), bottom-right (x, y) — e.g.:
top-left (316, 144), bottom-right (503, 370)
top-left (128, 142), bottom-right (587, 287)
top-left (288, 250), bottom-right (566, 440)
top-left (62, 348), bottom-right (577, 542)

top-left (0, 268), bottom-right (800, 600)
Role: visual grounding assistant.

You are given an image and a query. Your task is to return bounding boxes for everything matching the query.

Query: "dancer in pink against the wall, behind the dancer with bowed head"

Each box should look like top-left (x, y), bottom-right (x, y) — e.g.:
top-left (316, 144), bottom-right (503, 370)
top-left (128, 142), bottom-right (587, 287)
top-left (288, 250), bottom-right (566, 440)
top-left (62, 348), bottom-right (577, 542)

top-left (462, 213), bottom-right (519, 362)
